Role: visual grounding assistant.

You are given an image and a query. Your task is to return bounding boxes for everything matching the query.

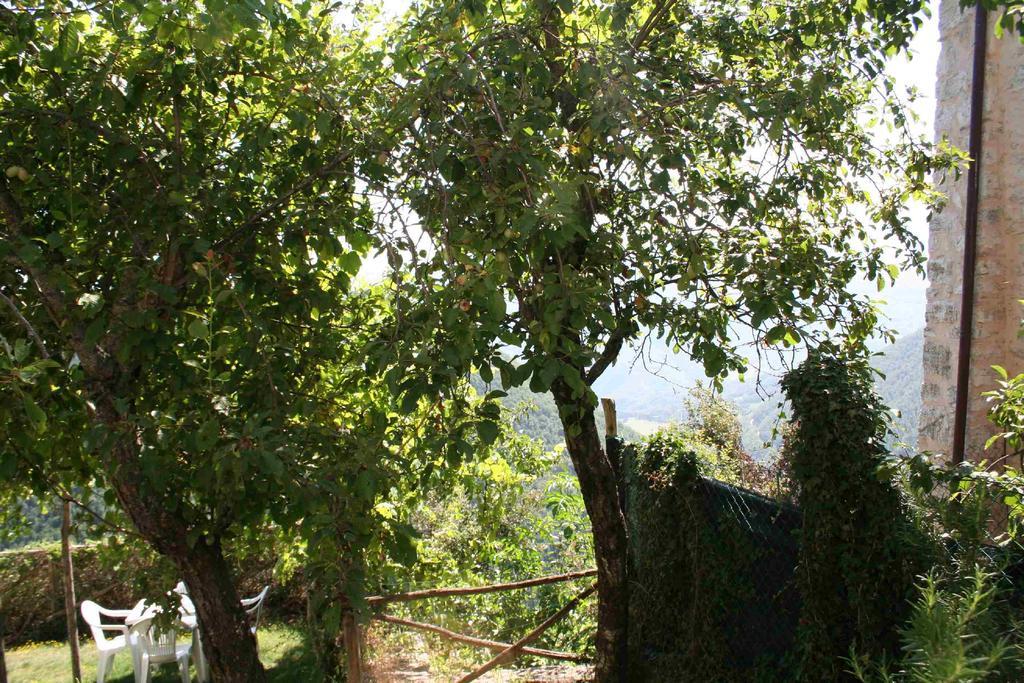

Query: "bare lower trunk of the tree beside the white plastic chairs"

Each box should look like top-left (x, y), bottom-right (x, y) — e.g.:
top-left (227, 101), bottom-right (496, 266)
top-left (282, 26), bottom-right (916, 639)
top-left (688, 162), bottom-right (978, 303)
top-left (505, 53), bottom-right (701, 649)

top-left (171, 540), bottom-right (266, 683)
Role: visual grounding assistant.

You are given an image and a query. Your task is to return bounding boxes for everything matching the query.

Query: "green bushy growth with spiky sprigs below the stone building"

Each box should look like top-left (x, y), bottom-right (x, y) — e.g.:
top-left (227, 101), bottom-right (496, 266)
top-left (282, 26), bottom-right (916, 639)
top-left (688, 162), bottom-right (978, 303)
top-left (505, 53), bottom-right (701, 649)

top-left (850, 454), bottom-right (1024, 683)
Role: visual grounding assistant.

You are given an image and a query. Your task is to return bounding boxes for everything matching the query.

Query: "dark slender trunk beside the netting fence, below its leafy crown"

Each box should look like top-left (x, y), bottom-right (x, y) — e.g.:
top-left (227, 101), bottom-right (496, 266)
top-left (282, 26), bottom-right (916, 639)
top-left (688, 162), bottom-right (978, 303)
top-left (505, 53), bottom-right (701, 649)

top-left (551, 381), bottom-right (629, 683)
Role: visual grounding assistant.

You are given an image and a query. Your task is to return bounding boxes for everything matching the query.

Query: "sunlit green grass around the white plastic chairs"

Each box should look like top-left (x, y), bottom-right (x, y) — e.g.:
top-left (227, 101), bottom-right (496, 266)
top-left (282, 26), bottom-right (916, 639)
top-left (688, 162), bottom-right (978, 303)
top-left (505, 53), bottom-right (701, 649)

top-left (6, 624), bottom-right (318, 683)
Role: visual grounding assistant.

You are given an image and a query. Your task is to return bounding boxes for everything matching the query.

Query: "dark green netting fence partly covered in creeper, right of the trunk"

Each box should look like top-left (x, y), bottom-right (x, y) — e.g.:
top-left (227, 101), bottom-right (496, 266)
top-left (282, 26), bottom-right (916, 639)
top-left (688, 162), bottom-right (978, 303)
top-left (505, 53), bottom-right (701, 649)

top-left (624, 447), bottom-right (801, 681)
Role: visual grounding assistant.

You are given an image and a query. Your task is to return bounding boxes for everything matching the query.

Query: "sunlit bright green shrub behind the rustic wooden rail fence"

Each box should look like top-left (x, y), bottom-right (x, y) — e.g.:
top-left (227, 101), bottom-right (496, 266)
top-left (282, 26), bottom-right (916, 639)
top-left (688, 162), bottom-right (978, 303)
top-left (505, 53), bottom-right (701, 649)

top-left (369, 429), bottom-right (595, 670)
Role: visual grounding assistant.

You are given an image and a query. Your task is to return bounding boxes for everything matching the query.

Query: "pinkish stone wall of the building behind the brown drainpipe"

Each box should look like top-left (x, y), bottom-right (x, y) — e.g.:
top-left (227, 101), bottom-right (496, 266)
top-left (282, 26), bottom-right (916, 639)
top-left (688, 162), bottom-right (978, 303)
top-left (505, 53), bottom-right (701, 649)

top-left (918, 0), bottom-right (1024, 460)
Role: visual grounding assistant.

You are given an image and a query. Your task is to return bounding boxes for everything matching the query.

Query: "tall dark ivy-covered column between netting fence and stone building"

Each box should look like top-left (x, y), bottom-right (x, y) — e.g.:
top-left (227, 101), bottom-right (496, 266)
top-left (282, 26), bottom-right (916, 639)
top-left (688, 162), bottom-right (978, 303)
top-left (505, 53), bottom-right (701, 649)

top-left (782, 349), bottom-right (930, 681)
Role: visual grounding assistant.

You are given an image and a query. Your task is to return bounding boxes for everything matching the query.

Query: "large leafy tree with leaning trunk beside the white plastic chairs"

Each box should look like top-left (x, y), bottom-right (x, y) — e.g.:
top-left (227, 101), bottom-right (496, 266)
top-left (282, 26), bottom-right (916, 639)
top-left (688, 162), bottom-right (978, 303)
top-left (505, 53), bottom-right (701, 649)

top-left (0, 0), bottom-right (368, 681)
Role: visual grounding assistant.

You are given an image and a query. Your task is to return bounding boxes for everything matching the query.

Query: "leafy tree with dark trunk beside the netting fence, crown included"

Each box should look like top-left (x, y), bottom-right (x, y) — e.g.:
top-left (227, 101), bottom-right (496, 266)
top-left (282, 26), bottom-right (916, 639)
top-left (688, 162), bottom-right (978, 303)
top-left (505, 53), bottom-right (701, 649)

top-left (357, 0), bottom-right (950, 681)
